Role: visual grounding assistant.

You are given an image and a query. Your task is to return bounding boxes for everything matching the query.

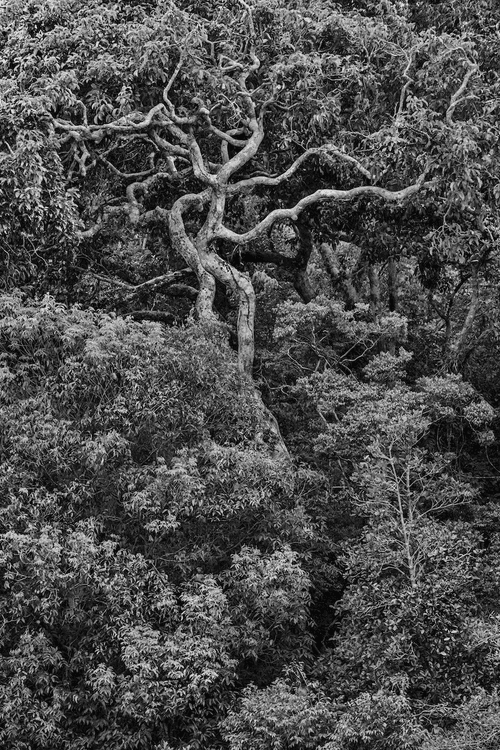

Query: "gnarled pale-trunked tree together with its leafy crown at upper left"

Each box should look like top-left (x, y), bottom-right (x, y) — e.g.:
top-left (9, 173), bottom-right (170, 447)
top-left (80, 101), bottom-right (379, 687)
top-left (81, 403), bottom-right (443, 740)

top-left (0, 2), bottom-right (442, 373)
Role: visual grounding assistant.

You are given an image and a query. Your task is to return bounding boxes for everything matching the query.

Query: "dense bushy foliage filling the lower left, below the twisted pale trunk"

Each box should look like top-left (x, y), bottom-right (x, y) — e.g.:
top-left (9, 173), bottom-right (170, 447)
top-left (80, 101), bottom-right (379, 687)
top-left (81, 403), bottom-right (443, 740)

top-left (0, 296), bottom-right (312, 748)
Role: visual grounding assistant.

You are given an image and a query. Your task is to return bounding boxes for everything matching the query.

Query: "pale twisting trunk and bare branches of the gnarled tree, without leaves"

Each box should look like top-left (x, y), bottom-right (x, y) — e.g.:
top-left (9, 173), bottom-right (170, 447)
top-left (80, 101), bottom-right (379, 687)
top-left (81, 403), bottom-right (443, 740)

top-left (62, 94), bottom-right (425, 375)
